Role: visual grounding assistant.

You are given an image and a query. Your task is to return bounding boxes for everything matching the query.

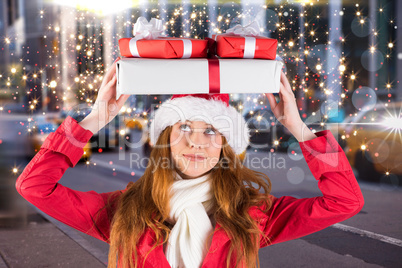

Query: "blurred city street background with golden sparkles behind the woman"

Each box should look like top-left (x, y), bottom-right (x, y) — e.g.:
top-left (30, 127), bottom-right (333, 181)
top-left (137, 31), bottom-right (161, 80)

top-left (0, 0), bottom-right (402, 268)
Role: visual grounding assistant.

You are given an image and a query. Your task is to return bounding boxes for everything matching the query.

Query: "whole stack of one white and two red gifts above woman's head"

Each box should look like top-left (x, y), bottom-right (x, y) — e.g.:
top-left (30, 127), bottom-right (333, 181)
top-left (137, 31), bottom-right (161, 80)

top-left (116, 17), bottom-right (282, 98)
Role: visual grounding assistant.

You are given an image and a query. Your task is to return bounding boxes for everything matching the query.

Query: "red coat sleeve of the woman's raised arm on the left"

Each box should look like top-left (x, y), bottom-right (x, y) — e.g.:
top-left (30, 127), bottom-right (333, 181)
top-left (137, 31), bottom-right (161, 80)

top-left (16, 116), bottom-right (119, 242)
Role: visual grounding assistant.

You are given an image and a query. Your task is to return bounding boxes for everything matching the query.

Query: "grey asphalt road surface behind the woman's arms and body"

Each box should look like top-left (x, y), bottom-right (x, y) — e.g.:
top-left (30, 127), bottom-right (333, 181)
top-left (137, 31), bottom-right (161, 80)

top-left (2, 116), bottom-right (402, 267)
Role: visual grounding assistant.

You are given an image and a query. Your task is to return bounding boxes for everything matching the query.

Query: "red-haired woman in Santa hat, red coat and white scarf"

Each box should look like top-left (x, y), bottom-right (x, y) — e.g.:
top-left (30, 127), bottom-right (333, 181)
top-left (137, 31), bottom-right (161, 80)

top-left (16, 57), bottom-right (364, 268)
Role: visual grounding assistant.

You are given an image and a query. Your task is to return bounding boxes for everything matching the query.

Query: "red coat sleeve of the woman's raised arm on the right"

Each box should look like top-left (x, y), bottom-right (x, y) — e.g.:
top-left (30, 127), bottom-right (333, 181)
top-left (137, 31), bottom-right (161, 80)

top-left (260, 130), bottom-right (364, 247)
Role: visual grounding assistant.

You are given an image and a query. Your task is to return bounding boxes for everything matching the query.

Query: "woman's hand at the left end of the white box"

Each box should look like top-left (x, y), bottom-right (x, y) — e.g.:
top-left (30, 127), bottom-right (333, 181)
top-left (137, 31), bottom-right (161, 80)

top-left (80, 57), bottom-right (130, 133)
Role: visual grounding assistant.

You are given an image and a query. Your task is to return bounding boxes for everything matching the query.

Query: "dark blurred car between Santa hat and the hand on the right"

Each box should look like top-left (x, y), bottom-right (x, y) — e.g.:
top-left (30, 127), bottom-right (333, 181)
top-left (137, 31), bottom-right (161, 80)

top-left (243, 106), bottom-right (292, 151)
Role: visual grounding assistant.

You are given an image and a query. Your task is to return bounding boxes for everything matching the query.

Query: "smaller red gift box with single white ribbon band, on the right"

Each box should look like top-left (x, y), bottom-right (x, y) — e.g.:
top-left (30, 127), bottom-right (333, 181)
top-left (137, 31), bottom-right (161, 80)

top-left (212, 34), bottom-right (278, 60)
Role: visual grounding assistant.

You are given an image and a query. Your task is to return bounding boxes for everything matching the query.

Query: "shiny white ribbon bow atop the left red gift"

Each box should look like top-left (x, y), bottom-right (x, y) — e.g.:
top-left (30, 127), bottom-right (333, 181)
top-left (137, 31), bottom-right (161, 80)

top-left (133, 17), bottom-right (163, 40)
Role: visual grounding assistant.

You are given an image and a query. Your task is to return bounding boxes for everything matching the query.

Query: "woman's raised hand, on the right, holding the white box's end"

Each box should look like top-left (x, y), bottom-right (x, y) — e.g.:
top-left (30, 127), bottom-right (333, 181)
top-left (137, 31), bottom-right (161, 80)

top-left (265, 72), bottom-right (303, 131)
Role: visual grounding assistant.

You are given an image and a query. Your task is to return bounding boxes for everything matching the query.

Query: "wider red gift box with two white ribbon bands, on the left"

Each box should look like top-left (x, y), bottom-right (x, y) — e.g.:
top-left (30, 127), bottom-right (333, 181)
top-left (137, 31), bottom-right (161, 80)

top-left (119, 37), bottom-right (208, 59)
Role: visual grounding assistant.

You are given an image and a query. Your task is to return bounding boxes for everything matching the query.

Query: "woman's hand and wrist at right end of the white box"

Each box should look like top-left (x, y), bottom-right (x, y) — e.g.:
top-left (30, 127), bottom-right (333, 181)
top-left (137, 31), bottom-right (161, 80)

top-left (265, 72), bottom-right (317, 142)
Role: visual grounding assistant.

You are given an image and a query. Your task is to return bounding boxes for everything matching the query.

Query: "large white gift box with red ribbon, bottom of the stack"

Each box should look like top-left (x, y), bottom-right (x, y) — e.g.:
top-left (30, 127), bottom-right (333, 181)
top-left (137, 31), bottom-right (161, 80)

top-left (116, 58), bottom-right (283, 98)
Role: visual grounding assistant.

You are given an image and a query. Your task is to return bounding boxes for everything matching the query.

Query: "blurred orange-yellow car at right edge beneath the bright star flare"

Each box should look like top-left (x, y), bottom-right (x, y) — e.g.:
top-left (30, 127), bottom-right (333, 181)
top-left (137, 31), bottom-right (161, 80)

top-left (329, 102), bottom-right (402, 181)
